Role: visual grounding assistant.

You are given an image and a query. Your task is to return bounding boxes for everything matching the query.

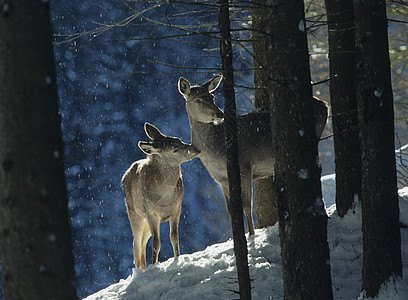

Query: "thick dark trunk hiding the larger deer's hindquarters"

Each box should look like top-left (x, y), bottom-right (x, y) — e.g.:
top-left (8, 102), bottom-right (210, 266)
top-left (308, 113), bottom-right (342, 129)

top-left (266, 0), bottom-right (333, 299)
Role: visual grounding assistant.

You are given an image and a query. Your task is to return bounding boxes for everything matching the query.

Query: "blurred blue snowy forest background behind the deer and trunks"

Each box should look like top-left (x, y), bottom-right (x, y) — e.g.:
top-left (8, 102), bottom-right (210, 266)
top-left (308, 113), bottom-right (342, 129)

top-left (0, 0), bottom-right (406, 298)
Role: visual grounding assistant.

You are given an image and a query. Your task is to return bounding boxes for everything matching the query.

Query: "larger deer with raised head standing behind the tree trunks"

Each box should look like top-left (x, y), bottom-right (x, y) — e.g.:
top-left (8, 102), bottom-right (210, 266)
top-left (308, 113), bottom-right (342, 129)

top-left (178, 74), bottom-right (328, 235)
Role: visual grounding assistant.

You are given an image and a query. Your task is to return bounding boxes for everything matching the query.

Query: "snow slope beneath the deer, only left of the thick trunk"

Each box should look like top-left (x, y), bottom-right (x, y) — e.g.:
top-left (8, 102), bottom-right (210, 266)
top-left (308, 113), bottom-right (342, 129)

top-left (86, 226), bottom-right (283, 300)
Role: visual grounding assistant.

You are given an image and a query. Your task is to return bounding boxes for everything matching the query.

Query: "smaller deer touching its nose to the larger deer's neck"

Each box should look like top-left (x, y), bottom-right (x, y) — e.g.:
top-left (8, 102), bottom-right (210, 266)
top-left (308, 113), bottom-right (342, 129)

top-left (121, 123), bottom-right (200, 269)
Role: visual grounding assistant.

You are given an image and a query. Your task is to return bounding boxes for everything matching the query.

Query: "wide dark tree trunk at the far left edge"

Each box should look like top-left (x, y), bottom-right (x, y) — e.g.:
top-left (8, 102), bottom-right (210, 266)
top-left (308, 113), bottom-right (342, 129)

top-left (0, 0), bottom-right (76, 300)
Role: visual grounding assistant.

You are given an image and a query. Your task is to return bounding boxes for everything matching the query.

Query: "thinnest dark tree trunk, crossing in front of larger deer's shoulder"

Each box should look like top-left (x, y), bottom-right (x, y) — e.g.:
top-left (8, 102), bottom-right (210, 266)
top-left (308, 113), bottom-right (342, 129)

top-left (219, 0), bottom-right (251, 299)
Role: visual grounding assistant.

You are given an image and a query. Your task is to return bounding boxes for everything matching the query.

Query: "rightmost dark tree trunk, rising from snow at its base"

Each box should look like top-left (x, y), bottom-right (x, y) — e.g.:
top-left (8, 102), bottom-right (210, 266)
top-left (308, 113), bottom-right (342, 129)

top-left (354, 0), bottom-right (402, 297)
